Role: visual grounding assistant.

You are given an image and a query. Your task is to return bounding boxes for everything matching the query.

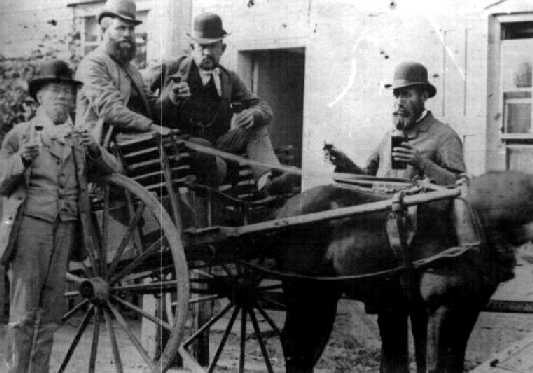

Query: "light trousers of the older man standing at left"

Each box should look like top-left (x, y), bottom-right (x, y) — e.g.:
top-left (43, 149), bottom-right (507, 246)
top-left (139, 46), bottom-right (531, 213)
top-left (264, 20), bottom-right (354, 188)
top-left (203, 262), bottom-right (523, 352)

top-left (6, 216), bottom-right (76, 373)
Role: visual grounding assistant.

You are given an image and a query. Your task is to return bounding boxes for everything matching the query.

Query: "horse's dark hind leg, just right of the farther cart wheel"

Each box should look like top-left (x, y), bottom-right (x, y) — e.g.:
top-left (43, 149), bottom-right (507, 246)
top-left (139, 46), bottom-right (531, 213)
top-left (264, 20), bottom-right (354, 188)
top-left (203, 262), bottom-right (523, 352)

top-left (281, 283), bottom-right (340, 373)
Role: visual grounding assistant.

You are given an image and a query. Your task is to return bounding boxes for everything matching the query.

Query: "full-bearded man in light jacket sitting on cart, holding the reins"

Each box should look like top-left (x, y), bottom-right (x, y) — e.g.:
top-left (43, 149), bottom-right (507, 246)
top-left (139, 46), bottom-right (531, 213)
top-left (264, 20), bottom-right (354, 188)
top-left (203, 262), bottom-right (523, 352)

top-left (76, 0), bottom-right (168, 143)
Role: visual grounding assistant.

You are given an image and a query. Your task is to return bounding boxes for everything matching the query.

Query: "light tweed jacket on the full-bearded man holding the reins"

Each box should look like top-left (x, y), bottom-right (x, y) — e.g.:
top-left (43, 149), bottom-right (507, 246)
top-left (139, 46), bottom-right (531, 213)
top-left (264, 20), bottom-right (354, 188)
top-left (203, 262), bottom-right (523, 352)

top-left (75, 46), bottom-right (158, 143)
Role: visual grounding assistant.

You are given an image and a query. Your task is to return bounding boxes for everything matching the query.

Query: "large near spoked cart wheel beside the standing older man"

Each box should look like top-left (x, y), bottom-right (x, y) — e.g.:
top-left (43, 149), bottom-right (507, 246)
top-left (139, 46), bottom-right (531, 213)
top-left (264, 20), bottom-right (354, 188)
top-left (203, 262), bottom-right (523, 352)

top-left (61, 174), bottom-right (189, 373)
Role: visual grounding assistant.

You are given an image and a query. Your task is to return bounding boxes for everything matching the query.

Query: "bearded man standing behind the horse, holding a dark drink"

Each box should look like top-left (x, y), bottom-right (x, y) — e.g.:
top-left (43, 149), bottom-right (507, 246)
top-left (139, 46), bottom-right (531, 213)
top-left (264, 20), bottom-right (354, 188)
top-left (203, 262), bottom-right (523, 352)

top-left (330, 62), bottom-right (466, 185)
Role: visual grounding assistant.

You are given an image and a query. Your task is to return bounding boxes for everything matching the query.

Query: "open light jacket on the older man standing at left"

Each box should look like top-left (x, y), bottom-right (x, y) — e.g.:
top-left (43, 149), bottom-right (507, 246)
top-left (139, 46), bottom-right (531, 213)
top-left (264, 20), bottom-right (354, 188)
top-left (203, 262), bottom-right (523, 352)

top-left (0, 116), bottom-right (120, 264)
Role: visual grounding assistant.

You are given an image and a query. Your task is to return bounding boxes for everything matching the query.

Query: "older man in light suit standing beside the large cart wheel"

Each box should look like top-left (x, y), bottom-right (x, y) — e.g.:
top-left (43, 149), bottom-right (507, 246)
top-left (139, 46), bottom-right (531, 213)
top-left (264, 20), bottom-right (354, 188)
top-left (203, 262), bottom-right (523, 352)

top-left (0, 60), bottom-right (119, 373)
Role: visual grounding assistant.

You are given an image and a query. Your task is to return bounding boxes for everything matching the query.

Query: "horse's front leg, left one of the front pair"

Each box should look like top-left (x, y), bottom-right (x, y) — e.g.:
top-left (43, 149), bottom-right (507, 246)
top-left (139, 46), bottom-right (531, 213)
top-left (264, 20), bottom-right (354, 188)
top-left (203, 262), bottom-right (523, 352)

top-left (378, 308), bottom-right (409, 373)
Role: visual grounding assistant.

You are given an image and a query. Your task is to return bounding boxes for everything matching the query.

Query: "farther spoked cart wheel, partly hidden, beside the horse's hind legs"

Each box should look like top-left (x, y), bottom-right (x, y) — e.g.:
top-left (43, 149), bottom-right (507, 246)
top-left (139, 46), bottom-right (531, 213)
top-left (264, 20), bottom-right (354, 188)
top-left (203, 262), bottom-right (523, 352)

top-left (181, 261), bottom-right (285, 373)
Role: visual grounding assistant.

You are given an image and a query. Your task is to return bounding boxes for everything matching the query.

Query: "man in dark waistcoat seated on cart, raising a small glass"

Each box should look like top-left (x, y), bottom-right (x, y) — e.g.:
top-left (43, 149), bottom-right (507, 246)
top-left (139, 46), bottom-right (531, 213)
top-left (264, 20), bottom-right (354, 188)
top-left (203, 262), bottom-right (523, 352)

top-left (149, 13), bottom-right (294, 191)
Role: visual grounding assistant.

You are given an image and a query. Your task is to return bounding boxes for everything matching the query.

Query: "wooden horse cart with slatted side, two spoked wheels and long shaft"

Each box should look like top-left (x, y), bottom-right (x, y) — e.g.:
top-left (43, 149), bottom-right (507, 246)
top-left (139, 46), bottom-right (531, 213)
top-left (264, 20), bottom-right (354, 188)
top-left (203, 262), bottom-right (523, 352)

top-left (58, 133), bottom-right (528, 373)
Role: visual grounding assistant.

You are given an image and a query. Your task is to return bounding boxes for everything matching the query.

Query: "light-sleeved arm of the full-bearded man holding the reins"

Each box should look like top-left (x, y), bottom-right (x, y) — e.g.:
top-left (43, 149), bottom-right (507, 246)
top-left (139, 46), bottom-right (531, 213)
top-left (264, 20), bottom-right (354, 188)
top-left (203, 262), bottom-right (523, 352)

top-left (76, 56), bottom-right (152, 131)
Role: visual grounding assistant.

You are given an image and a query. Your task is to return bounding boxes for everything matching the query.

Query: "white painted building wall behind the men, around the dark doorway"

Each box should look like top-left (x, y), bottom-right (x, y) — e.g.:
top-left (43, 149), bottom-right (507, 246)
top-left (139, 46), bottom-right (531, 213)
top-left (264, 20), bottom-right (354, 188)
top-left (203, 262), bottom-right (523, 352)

top-left (4, 0), bottom-right (533, 185)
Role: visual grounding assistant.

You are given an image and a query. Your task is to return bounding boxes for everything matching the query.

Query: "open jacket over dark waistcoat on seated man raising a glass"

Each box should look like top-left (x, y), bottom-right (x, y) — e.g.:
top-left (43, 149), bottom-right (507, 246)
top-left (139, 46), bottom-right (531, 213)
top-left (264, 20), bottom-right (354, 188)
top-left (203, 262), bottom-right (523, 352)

top-left (147, 56), bottom-right (272, 131)
